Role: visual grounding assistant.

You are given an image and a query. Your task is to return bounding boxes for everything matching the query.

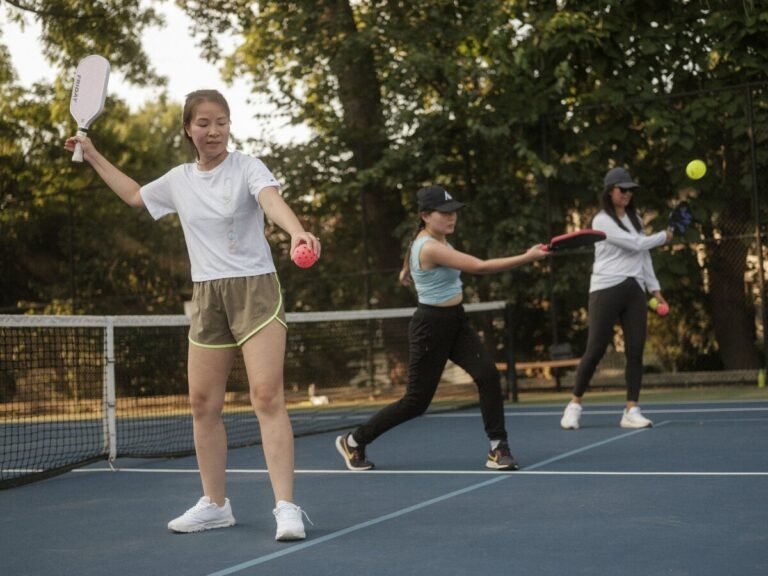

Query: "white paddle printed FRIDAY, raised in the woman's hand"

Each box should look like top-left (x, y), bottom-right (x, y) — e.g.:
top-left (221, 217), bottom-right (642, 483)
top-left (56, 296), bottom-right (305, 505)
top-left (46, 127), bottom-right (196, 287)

top-left (69, 54), bottom-right (109, 162)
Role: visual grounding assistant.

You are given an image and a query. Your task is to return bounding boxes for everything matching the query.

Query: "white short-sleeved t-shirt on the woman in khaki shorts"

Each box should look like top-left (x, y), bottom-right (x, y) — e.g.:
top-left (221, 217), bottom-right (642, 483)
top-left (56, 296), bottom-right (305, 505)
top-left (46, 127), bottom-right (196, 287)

top-left (141, 152), bottom-right (280, 282)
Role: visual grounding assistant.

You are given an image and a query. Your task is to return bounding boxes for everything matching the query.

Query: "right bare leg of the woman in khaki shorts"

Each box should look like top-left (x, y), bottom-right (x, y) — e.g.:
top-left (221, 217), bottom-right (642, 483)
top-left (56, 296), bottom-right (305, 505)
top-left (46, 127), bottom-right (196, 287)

top-left (243, 322), bottom-right (294, 502)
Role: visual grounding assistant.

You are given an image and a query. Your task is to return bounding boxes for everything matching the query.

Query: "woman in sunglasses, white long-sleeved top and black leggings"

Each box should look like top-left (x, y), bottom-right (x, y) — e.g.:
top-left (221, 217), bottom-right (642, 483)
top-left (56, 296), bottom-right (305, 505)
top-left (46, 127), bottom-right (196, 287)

top-left (560, 167), bottom-right (672, 430)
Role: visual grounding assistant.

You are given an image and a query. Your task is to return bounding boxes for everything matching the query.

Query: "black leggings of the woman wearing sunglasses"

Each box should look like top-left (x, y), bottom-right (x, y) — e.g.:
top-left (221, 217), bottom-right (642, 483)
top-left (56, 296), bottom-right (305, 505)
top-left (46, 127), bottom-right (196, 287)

top-left (573, 278), bottom-right (648, 402)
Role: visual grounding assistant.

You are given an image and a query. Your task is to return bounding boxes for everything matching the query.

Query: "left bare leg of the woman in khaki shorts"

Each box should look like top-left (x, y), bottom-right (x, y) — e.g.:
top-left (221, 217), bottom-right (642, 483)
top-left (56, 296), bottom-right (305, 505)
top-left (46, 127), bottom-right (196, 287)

top-left (187, 344), bottom-right (237, 506)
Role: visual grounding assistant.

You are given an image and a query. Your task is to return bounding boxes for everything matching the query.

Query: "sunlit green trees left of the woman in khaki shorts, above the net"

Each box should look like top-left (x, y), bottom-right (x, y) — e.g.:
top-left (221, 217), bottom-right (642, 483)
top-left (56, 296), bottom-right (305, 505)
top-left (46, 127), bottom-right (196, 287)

top-left (0, 1), bottom-right (188, 313)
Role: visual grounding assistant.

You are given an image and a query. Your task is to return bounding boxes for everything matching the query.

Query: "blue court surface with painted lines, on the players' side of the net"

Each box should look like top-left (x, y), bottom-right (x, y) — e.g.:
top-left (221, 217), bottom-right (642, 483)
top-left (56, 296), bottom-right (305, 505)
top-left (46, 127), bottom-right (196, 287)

top-left (0, 401), bottom-right (768, 576)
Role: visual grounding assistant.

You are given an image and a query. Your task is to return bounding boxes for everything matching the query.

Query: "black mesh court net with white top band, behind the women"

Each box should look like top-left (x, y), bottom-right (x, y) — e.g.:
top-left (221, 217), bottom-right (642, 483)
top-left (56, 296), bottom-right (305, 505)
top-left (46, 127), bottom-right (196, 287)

top-left (0, 302), bottom-right (507, 488)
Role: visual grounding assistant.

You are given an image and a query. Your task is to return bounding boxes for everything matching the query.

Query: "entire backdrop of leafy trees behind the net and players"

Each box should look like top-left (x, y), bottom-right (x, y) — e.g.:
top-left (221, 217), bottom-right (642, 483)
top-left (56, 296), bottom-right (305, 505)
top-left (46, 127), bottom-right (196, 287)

top-left (0, 0), bottom-right (768, 369)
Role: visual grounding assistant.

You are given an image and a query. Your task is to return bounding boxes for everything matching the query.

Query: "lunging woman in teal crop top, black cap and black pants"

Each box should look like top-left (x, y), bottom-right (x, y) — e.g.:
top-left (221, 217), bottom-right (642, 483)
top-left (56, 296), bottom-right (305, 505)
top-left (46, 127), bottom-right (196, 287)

top-left (336, 186), bottom-right (548, 470)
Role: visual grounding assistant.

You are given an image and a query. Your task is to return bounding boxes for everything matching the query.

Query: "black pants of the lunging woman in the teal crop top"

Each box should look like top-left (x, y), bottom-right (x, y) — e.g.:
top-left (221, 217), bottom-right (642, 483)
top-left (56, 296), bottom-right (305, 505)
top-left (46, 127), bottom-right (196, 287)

top-left (352, 304), bottom-right (507, 445)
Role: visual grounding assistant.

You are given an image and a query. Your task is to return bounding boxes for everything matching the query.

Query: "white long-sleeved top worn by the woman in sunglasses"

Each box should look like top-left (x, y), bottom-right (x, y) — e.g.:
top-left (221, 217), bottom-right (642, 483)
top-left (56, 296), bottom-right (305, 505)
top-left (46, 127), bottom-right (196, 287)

top-left (589, 210), bottom-right (667, 292)
